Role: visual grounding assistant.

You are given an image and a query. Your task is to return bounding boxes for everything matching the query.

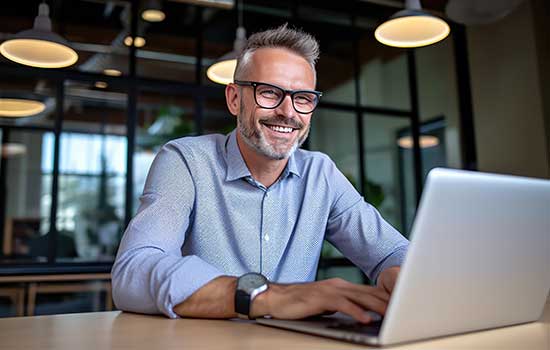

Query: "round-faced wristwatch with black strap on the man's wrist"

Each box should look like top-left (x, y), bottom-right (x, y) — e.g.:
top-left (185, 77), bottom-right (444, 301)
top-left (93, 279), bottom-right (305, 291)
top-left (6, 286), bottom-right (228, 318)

top-left (235, 272), bottom-right (269, 319)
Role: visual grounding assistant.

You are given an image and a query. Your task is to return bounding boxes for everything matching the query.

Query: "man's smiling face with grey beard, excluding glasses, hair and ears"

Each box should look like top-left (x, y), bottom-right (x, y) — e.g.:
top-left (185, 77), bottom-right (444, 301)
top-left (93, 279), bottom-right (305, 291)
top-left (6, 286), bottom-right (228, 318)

top-left (237, 48), bottom-right (315, 160)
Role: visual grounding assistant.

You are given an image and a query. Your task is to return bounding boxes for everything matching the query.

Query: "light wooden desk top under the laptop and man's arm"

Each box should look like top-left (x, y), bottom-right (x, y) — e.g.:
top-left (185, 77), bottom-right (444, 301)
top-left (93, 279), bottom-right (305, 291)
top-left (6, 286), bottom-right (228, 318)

top-left (0, 303), bottom-right (550, 350)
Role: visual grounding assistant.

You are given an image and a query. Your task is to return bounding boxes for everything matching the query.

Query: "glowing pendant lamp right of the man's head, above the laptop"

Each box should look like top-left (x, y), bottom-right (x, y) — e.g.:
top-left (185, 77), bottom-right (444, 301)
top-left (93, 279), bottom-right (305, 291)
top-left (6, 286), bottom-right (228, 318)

top-left (374, 0), bottom-right (451, 48)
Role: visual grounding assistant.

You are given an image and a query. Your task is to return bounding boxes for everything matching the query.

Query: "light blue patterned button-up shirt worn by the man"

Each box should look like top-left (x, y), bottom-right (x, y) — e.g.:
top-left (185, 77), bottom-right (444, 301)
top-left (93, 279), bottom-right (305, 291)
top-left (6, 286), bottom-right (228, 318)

top-left (112, 131), bottom-right (408, 318)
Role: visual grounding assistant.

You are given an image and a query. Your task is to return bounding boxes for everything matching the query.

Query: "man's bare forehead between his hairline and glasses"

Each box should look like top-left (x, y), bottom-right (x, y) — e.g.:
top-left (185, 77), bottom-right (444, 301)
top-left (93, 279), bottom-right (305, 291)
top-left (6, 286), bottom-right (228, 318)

top-left (248, 48), bottom-right (315, 89)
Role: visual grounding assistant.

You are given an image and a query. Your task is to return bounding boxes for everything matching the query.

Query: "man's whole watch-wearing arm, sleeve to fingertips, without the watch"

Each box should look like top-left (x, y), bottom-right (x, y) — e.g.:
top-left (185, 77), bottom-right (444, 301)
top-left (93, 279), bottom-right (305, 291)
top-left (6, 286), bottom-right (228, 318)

top-left (118, 147), bottom-right (404, 322)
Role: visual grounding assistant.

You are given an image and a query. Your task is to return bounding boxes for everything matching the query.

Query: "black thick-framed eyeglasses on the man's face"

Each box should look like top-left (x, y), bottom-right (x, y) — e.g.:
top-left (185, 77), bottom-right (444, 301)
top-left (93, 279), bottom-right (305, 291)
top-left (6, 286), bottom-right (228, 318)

top-left (235, 80), bottom-right (323, 114)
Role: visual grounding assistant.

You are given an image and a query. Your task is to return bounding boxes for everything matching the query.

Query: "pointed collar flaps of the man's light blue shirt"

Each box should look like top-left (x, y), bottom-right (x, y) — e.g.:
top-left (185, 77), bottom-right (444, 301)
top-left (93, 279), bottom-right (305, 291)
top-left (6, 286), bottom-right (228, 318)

top-left (225, 129), bottom-right (301, 181)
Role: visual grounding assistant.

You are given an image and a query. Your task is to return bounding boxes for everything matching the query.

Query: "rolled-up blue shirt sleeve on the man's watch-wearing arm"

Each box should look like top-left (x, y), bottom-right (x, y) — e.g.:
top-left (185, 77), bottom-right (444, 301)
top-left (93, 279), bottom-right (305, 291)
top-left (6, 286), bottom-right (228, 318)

top-left (111, 143), bottom-right (223, 318)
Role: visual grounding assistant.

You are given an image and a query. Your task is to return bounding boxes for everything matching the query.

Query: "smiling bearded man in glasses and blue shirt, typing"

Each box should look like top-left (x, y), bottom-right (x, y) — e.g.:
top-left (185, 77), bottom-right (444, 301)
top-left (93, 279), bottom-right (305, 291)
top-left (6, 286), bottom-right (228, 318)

top-left (112, 25), bottom-right (408, 323)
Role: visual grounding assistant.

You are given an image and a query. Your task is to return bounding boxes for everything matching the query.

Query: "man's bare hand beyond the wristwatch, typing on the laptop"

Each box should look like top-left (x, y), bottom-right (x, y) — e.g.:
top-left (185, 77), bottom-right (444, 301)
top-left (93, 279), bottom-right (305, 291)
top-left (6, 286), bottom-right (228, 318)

top-left (251, 278), bottom-right (390, 323)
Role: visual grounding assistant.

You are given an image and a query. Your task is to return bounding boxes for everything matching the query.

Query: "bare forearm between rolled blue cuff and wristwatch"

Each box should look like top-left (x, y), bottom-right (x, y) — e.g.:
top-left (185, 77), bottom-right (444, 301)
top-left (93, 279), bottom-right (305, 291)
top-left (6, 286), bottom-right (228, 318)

top-left (174, 276), bottom-right (237, 318)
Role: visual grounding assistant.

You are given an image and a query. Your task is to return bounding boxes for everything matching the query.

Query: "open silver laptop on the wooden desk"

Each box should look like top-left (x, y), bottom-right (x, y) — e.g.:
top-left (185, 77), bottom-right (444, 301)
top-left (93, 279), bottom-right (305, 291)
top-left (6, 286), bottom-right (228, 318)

top-left (256, 168), bottom-right (550, 346)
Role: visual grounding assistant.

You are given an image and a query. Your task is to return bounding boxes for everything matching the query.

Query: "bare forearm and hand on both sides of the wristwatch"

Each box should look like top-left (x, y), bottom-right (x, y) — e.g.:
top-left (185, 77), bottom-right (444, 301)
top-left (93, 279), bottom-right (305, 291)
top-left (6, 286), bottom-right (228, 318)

top-left (174, 276), bottom-right (389, 323)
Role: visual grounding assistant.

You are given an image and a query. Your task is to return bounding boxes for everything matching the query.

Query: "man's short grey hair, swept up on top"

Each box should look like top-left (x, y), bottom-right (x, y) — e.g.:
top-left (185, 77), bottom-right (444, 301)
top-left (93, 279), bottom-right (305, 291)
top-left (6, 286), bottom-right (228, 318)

top-left (234, 23), bottom-right (319, 80)
